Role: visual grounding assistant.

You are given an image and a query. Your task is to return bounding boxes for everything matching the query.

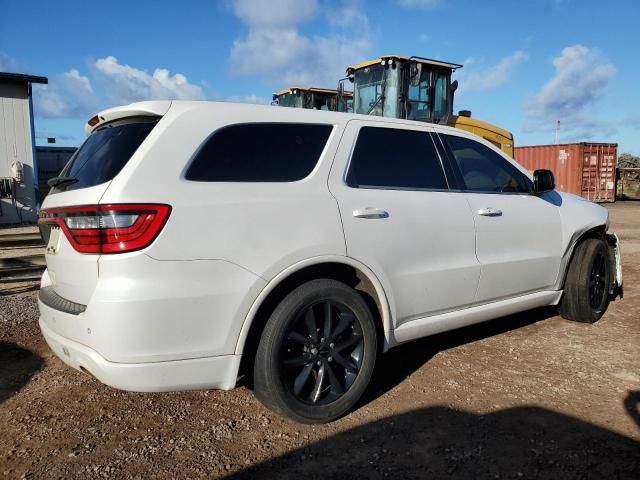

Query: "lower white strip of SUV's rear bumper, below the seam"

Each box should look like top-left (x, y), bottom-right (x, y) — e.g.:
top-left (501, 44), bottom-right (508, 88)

top-left (39, 317), bottom-right (241, 392)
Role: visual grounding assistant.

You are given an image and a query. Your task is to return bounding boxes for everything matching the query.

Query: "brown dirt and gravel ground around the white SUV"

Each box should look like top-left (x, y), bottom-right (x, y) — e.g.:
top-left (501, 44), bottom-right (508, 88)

top-left (0, 202), bottom-right (640, 480)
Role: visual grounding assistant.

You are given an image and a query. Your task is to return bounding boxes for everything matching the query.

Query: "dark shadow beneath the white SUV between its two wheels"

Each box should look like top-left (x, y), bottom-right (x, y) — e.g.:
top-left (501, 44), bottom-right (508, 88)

top-left (356, 307), bottom-right (558, 408)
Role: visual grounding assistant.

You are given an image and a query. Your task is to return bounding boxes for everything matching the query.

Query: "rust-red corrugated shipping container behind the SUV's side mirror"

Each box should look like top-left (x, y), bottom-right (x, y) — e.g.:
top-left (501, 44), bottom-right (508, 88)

top-left (514, 142), bottom-right (618, 202)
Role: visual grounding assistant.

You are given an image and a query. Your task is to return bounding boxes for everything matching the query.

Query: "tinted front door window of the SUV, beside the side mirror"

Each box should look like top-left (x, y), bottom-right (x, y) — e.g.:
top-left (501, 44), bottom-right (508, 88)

top-left (441, 135), bottom-right (530, 193)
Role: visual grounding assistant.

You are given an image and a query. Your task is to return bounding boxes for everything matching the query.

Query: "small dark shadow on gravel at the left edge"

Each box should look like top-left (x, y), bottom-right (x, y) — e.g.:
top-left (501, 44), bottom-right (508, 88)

top-left (0, 342), bottom-right (42, 403)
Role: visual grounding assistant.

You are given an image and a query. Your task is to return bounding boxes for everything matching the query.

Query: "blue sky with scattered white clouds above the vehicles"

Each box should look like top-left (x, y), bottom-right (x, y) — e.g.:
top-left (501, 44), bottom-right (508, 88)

top-left (0, 0), bottom-right (640, 155)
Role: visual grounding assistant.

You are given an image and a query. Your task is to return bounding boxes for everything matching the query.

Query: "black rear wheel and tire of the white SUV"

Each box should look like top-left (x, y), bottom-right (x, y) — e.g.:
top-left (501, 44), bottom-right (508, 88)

top-left (254, 279), bottom-right (378, 423)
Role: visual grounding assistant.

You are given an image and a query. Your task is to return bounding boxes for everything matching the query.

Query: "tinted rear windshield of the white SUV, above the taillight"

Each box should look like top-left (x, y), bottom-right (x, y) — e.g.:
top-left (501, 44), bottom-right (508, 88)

top-left (51, 117), bottom-right (158, 193)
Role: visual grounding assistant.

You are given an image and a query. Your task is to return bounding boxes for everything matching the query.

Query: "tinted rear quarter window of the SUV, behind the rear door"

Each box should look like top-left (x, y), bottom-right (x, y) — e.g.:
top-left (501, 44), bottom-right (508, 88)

top-left (186, 123), bottom-right (333, 182)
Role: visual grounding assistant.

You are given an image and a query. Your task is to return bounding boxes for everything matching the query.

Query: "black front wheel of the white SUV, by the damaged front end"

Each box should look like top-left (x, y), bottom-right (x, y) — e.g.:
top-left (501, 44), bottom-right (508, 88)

top-left (559, 238), bottom-right (611, 323)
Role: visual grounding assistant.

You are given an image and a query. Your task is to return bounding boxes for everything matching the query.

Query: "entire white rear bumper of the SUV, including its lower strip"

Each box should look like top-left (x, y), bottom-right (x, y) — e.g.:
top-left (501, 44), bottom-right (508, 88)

top-left (38, 252), bottom-right (265, 391)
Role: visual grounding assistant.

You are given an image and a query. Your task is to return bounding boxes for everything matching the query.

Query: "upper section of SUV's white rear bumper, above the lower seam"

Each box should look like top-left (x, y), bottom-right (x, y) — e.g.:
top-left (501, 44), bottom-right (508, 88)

top-left (38, 252), bottom-right (266, 364)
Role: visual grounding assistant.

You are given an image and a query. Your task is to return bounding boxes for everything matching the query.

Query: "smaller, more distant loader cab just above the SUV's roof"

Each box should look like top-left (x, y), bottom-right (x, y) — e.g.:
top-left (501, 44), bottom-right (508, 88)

top-left (271, 87), bottom-right (353, 112)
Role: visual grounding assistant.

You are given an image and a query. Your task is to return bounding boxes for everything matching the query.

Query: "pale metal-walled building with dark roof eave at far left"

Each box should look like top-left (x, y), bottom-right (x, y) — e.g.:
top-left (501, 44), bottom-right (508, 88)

top-left (0, 72), bottom-right (48, 225)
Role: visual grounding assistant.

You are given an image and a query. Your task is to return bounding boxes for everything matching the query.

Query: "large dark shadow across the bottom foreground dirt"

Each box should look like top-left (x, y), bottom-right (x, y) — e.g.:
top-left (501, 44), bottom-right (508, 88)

top-left (227, 407), bottom-right (640, 480)
